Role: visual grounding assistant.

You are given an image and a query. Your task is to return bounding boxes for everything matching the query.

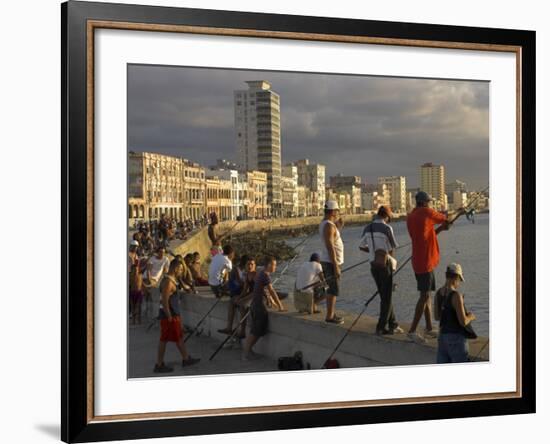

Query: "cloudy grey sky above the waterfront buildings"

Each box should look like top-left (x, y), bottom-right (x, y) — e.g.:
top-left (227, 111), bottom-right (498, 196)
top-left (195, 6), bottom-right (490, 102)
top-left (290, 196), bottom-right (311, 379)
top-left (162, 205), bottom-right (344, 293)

top-left (128, 65), bottom-right (489, 190)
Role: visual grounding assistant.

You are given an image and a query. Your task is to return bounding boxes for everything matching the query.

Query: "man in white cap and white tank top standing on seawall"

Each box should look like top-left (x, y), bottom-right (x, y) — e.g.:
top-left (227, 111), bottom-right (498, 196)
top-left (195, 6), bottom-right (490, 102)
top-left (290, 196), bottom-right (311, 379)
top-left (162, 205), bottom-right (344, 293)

top-left (319, 200), bottom-right (344, 324)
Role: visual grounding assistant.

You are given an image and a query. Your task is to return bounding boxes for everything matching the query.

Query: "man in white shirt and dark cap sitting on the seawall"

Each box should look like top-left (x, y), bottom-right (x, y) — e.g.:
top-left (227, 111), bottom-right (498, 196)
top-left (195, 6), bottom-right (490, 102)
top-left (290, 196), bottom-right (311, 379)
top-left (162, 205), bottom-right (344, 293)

top-left (294, 253), bottom-right (326, 314)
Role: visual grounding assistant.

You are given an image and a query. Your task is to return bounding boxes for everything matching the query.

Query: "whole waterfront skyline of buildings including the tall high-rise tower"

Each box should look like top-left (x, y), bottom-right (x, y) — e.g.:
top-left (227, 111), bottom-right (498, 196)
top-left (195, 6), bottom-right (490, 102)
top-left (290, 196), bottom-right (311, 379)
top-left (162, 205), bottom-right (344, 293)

top-left (128, 80), bottom-right (488, 220)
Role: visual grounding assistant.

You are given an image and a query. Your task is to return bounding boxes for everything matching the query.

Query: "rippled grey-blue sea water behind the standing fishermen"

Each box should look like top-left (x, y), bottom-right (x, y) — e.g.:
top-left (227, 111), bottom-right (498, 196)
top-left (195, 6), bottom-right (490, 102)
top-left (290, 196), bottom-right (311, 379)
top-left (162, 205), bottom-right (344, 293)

top-left (275, 213), bottom-right (489, 336)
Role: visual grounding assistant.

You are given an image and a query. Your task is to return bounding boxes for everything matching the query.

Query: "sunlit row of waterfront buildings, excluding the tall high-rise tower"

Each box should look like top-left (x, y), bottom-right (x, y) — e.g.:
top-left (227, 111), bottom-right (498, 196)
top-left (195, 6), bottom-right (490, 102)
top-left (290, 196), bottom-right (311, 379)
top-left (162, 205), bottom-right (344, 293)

top-left (128, 152), bottom-right (489, 220)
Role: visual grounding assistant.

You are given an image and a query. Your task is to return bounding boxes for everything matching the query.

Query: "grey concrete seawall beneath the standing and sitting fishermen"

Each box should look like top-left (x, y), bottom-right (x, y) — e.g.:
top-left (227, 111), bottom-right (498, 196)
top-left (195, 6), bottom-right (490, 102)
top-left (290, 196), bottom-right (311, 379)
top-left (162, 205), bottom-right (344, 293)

top-left (182, 288), bottom-right (489, 369)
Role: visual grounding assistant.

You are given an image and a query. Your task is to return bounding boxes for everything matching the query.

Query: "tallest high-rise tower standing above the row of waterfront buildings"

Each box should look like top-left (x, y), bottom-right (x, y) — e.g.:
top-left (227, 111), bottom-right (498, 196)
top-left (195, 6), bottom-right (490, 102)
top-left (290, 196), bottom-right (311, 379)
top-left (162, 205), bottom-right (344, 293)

top-left (234, 80), bottom-right (282, 216)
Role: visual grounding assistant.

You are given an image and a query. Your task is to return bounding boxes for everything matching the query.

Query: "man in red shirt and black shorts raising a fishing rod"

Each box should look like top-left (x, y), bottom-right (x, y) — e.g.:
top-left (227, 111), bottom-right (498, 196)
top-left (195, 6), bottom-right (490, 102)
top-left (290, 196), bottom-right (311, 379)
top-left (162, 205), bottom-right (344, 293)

top-left (407, 191), bottom-right (462, 343)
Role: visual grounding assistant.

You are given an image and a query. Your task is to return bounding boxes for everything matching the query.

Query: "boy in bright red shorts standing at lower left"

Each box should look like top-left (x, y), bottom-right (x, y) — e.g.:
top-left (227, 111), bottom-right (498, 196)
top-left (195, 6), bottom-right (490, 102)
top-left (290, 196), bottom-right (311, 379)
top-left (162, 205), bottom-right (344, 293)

top-left (153, 259), bottom-right (200, 373)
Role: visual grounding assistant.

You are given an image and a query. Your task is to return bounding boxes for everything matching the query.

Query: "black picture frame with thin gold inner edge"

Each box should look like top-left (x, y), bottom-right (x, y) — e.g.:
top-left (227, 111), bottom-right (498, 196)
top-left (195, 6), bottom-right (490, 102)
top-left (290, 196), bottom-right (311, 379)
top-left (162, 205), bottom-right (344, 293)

top-left (61, 1), bottom-right (536, 442)
